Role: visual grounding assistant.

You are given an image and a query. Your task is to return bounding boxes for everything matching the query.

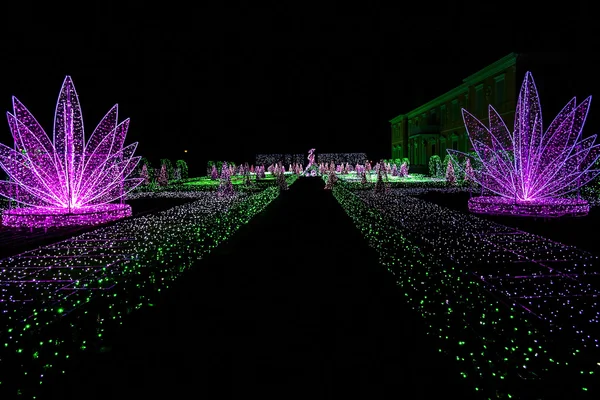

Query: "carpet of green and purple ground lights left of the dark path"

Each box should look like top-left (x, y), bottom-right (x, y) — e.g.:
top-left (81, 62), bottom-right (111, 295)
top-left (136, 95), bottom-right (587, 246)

top-left (0, 179), bottom-right (288, 398)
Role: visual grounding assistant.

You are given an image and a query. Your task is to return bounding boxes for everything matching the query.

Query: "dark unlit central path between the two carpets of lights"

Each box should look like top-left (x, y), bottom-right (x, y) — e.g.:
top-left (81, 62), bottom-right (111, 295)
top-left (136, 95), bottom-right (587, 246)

top-left (42, 179), bottom-right (478, 399)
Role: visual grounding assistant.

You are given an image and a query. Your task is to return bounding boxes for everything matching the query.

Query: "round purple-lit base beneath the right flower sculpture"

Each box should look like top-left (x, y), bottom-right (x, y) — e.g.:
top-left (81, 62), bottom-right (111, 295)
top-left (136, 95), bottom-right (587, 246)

top-left (469, 196), bottom-right (590, 218)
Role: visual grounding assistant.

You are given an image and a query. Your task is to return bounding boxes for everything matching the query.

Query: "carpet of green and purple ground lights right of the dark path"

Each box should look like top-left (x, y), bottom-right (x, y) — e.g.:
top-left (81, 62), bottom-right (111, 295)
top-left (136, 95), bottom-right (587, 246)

top-left (334, 177), bottom-right (600, 398)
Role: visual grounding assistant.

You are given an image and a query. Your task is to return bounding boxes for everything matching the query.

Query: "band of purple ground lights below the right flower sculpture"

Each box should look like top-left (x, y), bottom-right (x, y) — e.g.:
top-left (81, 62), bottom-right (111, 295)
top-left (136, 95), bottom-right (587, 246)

top-left (358, 189), bottom-right (600, 348)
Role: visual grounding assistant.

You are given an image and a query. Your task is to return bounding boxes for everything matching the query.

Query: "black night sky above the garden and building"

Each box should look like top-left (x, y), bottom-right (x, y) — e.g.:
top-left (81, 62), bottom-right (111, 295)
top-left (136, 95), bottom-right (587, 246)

top-left (0, 1), bottom-right (600, 173)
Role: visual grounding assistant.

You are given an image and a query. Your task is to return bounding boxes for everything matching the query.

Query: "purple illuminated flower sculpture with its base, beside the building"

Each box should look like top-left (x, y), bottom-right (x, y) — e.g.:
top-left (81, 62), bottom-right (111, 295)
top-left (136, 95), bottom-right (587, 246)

top-left (448, 72), bottom-right (600, 217)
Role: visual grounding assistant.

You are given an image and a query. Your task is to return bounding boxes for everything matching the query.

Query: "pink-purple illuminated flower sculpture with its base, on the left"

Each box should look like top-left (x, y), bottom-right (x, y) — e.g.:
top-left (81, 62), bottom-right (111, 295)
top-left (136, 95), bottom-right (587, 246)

top-left (0, 76), bottom-right (143, 227)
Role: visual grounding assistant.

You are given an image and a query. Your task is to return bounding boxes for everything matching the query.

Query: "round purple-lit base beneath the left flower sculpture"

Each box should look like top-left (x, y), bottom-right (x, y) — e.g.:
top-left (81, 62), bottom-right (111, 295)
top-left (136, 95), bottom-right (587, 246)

top-left (2, 203), bottom-right (131, 228)
